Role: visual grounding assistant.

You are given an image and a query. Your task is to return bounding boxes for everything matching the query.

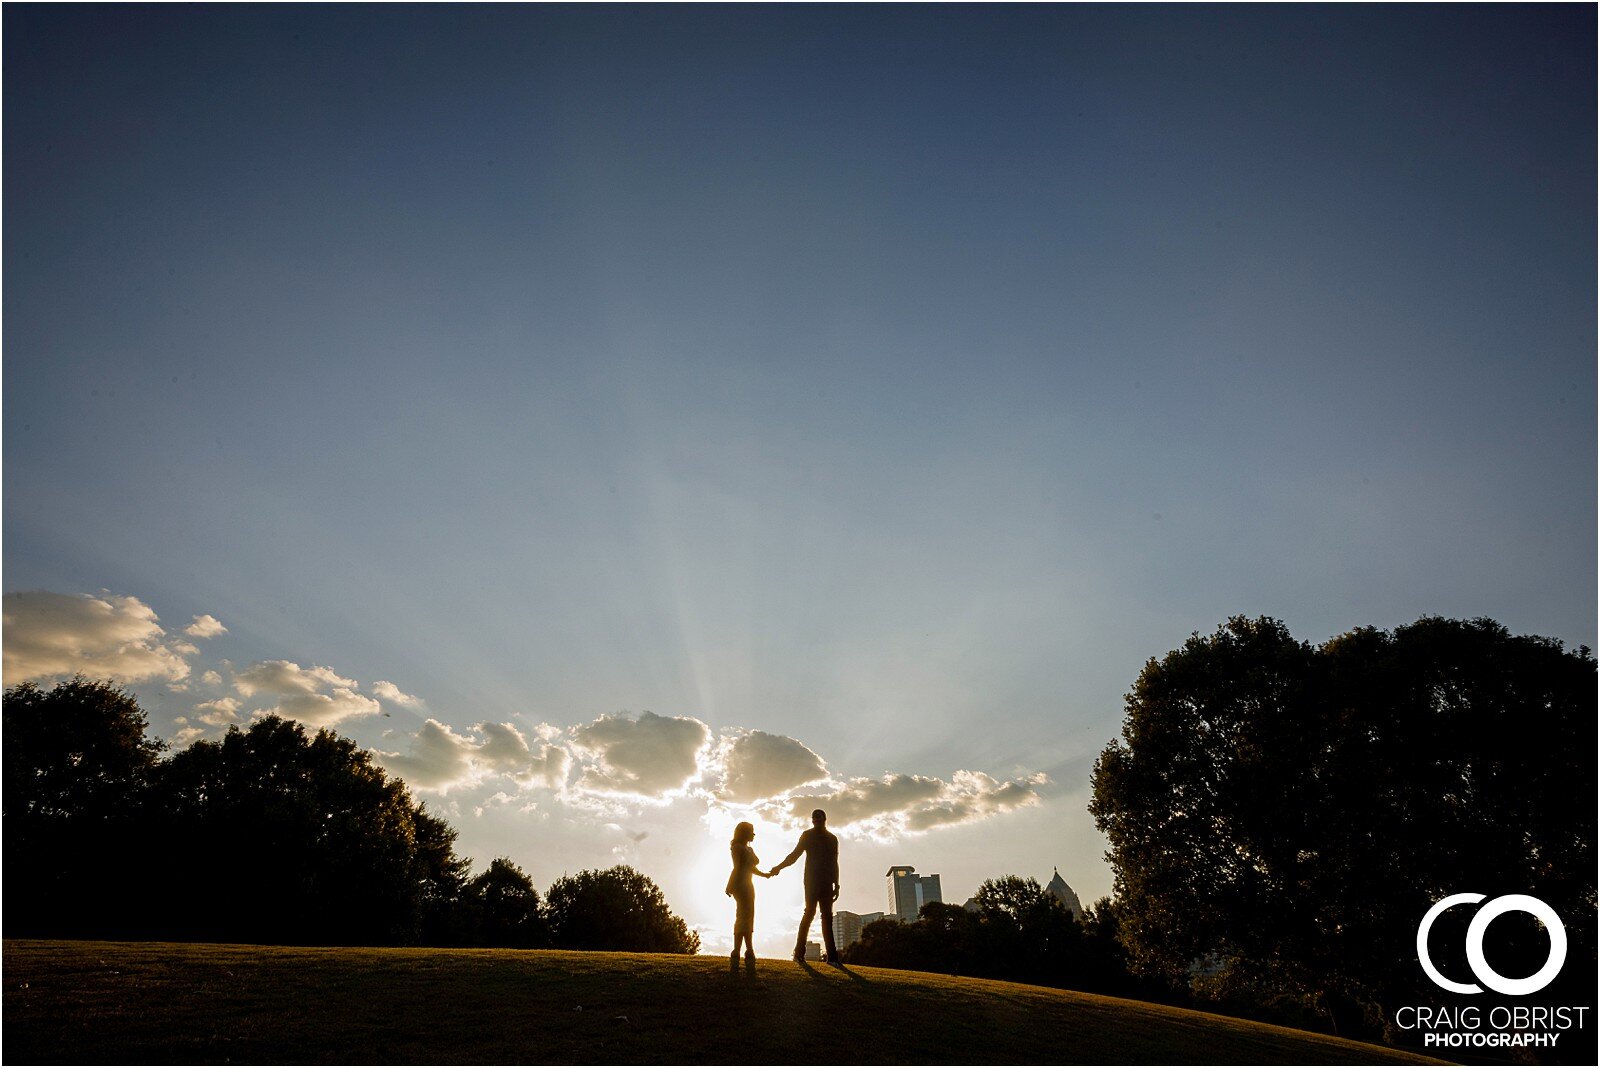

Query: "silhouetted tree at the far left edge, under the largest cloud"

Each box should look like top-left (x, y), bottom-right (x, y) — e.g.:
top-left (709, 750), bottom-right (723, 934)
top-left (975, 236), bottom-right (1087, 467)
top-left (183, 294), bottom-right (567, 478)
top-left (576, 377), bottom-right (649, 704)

top-left (0, 676), bottom-right (162, 935)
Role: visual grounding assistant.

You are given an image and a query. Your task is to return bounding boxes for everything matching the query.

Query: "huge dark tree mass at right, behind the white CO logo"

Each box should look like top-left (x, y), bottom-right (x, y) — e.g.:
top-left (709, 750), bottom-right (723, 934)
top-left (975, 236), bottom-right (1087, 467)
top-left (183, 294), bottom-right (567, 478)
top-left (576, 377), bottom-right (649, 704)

top-left (1090, 617), bottom-right (1595, 1030)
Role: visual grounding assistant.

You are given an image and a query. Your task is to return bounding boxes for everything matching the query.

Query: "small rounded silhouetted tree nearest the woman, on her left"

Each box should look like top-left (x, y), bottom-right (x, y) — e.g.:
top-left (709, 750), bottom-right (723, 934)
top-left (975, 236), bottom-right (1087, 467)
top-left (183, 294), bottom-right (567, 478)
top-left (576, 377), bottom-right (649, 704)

top-left (544, 865), bottom-right (699, 953)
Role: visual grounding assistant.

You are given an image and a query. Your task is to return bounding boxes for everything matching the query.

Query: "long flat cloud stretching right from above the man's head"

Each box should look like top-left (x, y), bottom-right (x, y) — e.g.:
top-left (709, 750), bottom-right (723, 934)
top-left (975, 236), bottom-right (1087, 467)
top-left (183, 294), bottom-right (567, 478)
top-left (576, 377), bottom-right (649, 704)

top-left (787, 771), bottom-right (1050, 839)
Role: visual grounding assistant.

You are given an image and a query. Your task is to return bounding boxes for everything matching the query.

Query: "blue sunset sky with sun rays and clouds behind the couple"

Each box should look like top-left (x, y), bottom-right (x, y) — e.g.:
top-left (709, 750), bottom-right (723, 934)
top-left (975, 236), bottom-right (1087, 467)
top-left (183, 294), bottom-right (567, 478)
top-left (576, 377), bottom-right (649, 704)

top-left (0, 5), bottom-right (1597, 954)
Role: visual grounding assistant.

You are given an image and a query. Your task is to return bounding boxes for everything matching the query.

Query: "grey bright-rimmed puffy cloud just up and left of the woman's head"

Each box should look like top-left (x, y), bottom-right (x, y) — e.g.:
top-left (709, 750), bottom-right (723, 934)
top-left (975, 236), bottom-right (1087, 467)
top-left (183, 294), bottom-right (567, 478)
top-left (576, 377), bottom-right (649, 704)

top-left (571, 711), bottom-right (710, 799)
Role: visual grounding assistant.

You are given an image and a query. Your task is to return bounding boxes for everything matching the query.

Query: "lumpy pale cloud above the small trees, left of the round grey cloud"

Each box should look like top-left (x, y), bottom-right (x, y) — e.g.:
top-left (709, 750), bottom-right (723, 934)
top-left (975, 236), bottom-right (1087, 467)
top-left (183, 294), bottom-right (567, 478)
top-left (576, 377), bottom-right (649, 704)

top-left (378, 719), bottom-right (571, 793)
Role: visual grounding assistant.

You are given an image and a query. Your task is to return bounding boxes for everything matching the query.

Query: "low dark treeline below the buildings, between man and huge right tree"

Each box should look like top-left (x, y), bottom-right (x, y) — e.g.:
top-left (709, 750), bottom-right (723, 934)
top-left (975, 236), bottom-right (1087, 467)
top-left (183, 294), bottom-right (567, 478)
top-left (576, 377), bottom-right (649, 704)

top-left (845, 875), bottom-right (1171, 999)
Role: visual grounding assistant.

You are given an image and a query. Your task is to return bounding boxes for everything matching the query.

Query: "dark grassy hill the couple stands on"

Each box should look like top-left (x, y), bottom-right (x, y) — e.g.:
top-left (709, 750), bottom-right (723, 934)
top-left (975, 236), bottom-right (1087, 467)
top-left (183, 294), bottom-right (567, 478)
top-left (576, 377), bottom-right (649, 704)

top-left (0, 940), bottom-right (1452, 1065)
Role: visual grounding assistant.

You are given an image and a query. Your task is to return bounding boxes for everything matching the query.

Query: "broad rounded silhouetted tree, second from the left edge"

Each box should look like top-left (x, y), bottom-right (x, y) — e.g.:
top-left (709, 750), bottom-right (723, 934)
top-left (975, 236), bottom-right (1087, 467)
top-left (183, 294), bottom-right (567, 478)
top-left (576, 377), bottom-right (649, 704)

top-left (162, 716), bottom-right (459, 943)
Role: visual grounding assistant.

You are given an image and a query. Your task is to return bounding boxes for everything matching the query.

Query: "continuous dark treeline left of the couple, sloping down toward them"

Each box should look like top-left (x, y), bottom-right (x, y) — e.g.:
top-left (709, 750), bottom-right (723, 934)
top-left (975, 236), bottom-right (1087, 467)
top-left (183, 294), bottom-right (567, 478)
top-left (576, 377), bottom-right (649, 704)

top-left (0, 678), bottom-right (699, 953)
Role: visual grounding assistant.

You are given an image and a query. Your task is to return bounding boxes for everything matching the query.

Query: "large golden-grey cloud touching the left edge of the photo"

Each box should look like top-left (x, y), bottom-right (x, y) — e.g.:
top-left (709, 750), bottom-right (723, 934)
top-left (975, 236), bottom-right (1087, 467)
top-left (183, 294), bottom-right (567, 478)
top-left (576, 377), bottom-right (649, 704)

top-left (3, 590), bottom-right (189, 686)
